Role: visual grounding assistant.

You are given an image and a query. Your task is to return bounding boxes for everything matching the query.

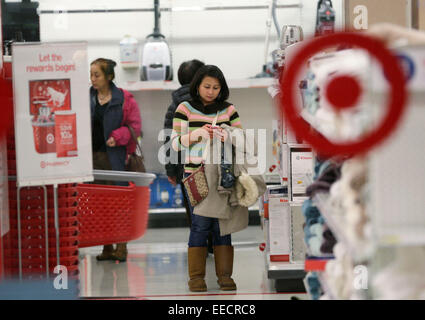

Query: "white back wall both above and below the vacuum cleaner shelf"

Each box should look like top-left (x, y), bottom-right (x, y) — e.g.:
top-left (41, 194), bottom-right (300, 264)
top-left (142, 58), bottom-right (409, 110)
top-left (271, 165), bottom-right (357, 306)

top-left (39, 0), bottom-right (342, 173)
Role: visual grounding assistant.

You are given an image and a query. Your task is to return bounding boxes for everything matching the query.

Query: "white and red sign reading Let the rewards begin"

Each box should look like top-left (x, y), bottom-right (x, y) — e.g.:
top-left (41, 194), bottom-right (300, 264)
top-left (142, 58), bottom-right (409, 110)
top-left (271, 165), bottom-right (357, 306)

top-left (12, 43), bottom-right (93, 186)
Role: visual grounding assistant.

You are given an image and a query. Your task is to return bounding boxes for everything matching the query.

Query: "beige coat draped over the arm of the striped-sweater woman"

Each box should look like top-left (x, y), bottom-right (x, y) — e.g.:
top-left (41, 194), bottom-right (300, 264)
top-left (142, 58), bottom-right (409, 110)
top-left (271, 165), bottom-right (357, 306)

top-left (193, 125), bottom-right (266, 236)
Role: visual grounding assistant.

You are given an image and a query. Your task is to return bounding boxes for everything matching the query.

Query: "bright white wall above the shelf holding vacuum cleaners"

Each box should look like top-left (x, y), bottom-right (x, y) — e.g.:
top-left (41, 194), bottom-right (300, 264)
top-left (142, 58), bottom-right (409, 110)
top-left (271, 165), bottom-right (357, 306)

top-left (39, 0), bottom-right (342, 82)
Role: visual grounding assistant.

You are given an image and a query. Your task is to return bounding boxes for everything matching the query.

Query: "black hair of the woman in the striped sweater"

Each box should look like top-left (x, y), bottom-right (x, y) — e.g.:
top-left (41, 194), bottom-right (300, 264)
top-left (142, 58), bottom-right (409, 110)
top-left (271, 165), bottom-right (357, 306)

top-left (190, 65), bottom-right (229, 102)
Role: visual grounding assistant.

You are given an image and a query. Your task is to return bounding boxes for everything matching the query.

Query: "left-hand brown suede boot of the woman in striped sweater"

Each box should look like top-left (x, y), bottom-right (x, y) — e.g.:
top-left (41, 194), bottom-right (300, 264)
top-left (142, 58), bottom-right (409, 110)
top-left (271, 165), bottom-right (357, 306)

top-left (187, 247), bottom-right (207, 292)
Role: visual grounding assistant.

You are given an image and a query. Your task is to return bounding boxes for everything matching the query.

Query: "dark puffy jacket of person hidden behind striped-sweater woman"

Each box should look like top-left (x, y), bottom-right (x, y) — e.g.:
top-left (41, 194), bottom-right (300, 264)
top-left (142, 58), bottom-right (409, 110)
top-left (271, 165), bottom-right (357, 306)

top-left (164, 84), bottom-right (191, 183)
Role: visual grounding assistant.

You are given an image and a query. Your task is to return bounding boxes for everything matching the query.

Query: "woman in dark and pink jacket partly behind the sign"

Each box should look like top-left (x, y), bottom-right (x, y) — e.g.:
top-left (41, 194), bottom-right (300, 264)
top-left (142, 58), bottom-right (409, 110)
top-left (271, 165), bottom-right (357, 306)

top-left (90, 58), bottom-right (141, 261)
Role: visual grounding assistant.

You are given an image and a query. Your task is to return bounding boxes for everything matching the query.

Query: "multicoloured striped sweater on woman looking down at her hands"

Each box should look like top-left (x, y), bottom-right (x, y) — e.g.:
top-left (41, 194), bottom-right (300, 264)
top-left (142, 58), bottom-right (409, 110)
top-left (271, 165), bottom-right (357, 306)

top-left (171, 102), bottom-right (242, 173)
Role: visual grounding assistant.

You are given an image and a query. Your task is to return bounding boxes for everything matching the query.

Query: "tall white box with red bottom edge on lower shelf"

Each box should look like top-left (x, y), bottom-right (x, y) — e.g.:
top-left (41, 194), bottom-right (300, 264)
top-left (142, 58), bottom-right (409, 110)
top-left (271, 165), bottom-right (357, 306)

top-left (269, 197), bottom-right (291, 262)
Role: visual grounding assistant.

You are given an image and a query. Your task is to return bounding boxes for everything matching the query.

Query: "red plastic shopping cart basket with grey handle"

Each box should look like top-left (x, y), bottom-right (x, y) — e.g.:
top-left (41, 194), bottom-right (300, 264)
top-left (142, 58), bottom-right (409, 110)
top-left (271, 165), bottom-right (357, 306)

top-left (77, 170), bottom-right (155, 248)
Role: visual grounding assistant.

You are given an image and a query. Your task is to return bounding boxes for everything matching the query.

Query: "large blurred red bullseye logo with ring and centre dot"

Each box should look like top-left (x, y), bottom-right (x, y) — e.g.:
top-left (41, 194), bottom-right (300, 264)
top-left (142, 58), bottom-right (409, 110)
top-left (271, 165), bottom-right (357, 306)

top-left (280, 33), bottom-right (407, 157)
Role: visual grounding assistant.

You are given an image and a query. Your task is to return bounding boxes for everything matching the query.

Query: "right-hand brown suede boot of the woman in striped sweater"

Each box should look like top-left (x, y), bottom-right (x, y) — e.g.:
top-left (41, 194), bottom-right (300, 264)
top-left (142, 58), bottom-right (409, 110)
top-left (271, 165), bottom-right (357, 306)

top-left (214, 246), bottom-right (236, 291)
